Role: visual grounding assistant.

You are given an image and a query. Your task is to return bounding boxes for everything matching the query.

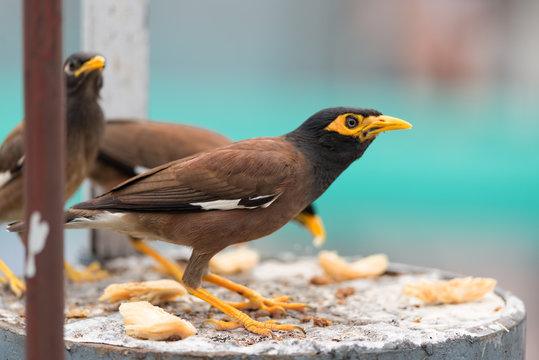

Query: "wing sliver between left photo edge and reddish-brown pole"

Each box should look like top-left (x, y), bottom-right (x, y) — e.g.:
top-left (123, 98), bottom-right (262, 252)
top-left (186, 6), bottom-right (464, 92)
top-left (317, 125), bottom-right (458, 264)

top-left (0, 124), bottom-right (24, 188)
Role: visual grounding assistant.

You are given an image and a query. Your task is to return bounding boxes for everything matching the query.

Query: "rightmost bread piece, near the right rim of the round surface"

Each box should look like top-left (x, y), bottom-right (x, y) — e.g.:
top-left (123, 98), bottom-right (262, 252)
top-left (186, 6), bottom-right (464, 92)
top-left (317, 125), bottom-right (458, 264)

top-left (404, 277), bottom-right (496, 304)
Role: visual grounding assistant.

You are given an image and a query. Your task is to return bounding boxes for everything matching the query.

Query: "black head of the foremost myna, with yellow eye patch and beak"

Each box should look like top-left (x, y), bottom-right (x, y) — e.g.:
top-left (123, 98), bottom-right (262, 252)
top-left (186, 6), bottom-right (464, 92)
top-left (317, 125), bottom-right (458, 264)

top-left (287, 107), bottom-right (412, 172)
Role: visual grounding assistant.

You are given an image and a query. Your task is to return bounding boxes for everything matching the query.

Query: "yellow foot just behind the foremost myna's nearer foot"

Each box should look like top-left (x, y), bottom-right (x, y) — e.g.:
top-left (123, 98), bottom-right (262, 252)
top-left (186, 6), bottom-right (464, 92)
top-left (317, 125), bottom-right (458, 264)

top-left (229, 296), bottom-right (307, 318)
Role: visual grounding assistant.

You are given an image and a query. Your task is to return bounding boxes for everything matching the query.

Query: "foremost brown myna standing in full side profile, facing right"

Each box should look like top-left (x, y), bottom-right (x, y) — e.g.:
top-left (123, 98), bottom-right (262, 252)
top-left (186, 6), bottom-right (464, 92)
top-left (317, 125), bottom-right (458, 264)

top-left (9, 107), bottom-right (411, 335)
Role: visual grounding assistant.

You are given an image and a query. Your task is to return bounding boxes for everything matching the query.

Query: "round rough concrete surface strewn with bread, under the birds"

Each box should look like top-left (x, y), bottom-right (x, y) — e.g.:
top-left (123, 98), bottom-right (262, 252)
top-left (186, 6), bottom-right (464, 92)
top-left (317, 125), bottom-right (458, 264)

top-left (0, 257), bottom-right (525, 359)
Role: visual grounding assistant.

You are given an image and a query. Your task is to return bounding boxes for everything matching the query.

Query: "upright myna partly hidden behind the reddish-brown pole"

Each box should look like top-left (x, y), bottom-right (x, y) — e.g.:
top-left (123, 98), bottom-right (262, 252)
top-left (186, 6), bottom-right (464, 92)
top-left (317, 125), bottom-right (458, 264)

top-left (0, 53), bottom-right (105, 295)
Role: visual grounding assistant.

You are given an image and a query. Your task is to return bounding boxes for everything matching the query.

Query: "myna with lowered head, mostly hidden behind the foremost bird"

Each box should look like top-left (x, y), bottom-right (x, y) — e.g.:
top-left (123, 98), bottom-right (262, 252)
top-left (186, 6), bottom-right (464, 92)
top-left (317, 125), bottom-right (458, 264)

top-left (90, 119), bottom-right (325, 288)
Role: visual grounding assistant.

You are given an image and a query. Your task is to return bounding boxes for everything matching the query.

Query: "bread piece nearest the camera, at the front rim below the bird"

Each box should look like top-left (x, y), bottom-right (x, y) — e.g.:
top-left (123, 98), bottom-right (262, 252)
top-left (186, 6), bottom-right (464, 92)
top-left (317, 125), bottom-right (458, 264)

top-left (120, 301), bottom-right (197, 340)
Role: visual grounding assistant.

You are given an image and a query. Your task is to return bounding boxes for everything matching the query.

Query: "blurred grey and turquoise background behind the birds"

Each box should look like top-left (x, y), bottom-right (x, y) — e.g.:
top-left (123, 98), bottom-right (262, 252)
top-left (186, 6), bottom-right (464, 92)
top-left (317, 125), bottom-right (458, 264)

top-left (0, 0), bottom-right (539, 359)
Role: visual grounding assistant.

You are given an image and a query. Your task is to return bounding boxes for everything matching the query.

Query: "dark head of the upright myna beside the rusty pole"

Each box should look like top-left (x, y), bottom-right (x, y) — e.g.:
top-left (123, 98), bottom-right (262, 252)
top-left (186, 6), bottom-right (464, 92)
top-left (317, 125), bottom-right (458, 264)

top-left (64, 52), bottom-right (105, 98)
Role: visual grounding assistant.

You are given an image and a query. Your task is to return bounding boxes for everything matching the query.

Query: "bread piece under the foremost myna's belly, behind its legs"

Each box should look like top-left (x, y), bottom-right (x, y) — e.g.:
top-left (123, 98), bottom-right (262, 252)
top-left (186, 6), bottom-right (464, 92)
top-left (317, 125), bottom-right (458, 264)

top-left (210, 246), bottom-right (260, 275)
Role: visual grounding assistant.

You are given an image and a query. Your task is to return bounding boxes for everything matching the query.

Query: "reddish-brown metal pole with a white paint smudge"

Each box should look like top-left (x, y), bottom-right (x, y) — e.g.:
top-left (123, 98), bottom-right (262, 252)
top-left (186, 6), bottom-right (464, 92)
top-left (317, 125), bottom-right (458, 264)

top-left (24, 0), bottom-right (65, 360)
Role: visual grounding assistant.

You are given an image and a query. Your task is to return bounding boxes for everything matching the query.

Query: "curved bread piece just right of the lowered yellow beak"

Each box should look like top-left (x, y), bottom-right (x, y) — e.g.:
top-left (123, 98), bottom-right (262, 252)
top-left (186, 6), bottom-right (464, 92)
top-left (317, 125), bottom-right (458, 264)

top-left (318, 251), bottom-right (389, 282)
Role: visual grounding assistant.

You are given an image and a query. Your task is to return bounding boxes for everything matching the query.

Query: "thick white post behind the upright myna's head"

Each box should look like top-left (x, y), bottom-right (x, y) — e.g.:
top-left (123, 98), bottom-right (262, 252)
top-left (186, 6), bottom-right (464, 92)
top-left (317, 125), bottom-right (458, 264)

top-left (81, 0), bottom-right (150, 258)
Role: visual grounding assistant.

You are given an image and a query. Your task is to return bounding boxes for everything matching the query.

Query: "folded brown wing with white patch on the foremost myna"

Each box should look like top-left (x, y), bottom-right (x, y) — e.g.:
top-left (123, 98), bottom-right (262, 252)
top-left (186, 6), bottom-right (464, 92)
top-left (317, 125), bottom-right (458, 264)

top-left (75, 140), bottom-right (297, 212)
